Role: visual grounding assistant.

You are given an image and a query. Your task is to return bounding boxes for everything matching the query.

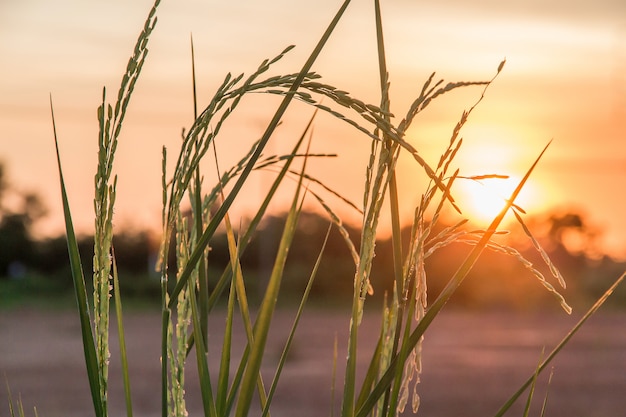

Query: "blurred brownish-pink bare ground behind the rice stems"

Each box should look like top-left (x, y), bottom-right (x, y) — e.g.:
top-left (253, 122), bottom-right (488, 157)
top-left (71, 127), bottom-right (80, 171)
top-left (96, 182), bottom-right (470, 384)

top-left (0, 309), bottom-right (626, 417)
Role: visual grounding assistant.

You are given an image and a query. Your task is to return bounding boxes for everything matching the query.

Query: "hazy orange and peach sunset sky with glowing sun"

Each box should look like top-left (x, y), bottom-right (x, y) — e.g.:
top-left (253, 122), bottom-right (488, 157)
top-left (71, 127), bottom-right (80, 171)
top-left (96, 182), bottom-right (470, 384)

top-left (0, 0), bottom-right (626, 257)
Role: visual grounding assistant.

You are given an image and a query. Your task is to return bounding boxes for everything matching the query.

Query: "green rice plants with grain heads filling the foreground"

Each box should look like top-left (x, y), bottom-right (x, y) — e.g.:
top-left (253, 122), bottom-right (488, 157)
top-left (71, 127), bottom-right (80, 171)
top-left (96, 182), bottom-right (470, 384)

top-left (47, 0), bottom-right (623, 417)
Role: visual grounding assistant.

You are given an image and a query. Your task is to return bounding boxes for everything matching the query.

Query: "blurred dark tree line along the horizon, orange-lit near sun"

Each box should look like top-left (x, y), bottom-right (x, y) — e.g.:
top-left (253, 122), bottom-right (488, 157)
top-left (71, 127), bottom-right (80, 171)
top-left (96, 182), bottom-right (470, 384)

top-left (0, 160), bottom-right (626, 309)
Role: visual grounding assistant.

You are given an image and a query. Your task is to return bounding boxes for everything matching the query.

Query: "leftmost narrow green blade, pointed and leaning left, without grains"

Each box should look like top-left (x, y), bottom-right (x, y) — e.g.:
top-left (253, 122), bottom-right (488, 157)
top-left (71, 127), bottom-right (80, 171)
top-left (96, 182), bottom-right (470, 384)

top-left (50, 97), bottom-right (105, 417)
